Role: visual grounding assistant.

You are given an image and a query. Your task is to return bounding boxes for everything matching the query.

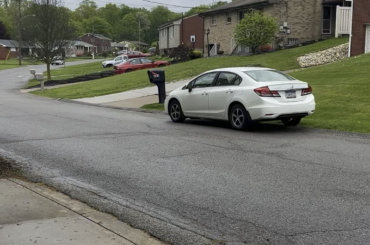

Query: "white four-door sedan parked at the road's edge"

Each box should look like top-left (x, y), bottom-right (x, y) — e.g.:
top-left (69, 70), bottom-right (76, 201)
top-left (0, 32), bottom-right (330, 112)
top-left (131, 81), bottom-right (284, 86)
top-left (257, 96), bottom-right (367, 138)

top-left (165, 67), bottom-right (316, 130)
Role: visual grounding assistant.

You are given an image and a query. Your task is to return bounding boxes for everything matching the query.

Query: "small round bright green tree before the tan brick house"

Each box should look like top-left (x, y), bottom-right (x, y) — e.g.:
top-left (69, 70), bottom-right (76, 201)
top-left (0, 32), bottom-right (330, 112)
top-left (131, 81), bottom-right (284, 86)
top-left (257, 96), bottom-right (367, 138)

top-left (235, 9), bottom-right (278, 54)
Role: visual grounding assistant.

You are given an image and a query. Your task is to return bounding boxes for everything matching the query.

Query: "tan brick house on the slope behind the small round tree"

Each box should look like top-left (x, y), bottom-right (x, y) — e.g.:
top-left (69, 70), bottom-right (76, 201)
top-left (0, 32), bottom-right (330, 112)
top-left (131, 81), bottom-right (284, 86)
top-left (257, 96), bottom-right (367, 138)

top-left (200, 0), bottom-right (351, 56)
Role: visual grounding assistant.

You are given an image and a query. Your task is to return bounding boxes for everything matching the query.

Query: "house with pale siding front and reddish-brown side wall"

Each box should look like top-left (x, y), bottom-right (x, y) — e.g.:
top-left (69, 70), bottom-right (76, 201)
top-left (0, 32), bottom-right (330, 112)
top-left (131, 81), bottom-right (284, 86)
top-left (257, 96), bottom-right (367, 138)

top-left (158, 15), bottom-right (204, 55)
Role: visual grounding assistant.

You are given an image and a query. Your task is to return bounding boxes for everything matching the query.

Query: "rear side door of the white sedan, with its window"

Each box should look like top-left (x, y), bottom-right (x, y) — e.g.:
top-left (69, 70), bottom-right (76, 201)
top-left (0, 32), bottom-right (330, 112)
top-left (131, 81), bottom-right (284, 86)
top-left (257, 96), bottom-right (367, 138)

top-left (209, 72), bottom-right (242, 119)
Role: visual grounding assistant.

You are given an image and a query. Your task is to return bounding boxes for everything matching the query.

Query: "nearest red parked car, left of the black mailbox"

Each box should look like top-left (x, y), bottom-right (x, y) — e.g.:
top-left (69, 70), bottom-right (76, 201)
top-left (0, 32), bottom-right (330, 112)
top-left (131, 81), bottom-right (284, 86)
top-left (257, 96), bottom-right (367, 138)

top-left (113, 58), bottom-right (170, 75)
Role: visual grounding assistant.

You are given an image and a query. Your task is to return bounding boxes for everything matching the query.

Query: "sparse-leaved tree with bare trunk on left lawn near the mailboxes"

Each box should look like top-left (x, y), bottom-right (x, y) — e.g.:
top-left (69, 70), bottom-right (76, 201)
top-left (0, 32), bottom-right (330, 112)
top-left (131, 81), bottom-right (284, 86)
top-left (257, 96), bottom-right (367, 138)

top-left (23, 0), bottom-right (75, 80)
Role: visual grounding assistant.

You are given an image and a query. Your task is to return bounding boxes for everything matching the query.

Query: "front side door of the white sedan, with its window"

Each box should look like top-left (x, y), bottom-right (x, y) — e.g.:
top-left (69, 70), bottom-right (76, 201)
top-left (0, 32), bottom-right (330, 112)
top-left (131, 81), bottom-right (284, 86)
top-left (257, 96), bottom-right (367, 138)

top-left (181, 72), bottom-right (217, 117)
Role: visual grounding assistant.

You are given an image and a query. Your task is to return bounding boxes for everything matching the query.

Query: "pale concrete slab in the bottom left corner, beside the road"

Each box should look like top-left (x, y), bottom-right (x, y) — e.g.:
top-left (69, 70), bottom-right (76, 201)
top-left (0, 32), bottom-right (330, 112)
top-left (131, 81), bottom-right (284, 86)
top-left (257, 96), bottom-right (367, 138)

top-left (0, 179), bottom-right (165, 245)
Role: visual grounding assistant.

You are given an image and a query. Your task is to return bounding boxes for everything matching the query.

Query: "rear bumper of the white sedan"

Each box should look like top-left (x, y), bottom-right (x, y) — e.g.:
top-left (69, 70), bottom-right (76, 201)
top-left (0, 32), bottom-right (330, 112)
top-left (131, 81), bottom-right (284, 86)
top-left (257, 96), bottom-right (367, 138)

top-left (248, 96), bottom-right (316, 121)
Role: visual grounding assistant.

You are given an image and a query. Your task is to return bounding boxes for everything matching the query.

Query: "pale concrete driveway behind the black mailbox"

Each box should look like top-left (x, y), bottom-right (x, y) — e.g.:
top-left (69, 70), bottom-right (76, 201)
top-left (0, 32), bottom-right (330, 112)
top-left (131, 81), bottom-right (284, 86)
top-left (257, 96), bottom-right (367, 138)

top-left (75, 79), bottom-right (190, 108)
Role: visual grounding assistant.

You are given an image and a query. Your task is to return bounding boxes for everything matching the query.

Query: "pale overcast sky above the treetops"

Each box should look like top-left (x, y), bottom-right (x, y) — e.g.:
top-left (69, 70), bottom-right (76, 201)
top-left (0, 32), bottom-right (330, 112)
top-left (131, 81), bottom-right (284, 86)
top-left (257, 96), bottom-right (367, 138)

top-left (63, 0), bottom-right (230, 12)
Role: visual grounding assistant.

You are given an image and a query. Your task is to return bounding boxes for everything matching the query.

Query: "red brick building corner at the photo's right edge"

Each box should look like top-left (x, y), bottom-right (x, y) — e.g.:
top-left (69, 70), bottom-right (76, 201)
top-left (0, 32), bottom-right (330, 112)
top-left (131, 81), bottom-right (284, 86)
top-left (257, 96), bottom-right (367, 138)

top-left (350, 0), bottom-right (370, 56)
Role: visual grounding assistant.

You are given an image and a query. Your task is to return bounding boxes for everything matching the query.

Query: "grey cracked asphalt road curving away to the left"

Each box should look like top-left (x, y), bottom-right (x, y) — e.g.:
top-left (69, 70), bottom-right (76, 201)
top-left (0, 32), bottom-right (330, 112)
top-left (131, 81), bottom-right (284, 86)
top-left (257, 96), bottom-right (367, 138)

top-left (0, 61), bottom-right (370, 245)
